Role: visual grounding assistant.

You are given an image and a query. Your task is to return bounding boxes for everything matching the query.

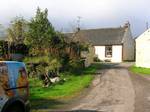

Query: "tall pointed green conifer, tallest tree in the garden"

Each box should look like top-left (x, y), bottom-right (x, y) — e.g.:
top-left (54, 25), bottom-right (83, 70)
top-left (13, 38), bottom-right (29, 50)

top-left (25, 8), bottom-right (55, 55)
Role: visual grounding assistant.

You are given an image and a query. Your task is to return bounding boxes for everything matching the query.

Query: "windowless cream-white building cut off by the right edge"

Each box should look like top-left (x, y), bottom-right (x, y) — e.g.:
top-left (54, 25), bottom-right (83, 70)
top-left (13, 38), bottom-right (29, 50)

top-left (136, 29), bottom-right (150, 68)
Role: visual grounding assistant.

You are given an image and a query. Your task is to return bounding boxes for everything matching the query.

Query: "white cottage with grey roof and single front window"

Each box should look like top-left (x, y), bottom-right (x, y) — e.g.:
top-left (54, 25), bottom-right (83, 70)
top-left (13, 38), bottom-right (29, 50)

top-left (65, 23), bottom-right (135, 62)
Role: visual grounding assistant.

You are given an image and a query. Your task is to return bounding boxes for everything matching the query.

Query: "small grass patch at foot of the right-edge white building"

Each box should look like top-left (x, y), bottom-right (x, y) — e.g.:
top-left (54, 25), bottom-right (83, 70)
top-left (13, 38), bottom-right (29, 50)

top-left (130, 66), bottom-right (150, 75)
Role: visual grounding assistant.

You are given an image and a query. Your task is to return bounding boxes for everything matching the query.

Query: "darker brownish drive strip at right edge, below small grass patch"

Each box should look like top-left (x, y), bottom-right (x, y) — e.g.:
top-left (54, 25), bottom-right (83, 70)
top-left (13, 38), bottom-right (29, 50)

top-left (130, 73), bottom-right (150, 112)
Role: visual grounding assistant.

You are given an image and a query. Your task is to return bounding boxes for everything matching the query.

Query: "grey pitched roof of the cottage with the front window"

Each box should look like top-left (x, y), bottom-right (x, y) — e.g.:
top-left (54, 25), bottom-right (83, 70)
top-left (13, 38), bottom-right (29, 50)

top-left (66, 27), bottom-right (125, 46)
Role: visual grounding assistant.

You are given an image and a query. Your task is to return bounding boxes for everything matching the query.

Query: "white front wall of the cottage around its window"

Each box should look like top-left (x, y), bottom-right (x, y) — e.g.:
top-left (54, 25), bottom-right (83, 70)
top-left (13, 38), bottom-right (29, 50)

top-left (95, 45), bottom-right (122, 62)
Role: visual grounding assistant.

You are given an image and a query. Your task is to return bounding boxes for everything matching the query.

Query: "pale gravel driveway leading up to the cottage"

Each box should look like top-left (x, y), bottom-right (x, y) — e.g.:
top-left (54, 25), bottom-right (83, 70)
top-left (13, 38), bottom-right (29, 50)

top-left (71, 64), bottom-right (135, 112)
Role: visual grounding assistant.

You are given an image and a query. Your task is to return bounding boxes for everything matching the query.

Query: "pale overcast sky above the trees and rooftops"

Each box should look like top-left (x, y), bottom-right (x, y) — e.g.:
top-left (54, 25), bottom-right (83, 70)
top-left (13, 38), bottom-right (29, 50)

top-left (0, 0), bottom-right (150, 36)
